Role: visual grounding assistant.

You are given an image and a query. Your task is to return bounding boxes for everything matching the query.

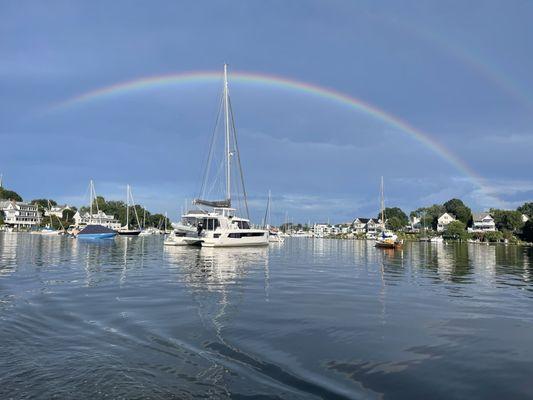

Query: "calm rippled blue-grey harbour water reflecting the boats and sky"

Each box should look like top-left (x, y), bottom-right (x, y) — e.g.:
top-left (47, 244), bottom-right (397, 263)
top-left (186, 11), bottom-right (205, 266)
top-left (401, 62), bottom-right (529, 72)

top-left (0, 233), bottom-right (533, 399)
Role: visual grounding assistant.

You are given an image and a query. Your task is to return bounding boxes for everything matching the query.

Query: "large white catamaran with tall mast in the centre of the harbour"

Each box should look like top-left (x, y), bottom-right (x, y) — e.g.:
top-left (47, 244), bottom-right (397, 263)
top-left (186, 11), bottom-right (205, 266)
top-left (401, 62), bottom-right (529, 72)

top-left (181, 64), bottom-right (268, 247)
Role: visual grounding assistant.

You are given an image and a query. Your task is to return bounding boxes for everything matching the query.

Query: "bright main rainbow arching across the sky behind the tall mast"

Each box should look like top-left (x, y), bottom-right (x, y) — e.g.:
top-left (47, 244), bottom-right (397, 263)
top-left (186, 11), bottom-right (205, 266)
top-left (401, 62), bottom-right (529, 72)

top-left (48, 71), bottom-right (486, 191)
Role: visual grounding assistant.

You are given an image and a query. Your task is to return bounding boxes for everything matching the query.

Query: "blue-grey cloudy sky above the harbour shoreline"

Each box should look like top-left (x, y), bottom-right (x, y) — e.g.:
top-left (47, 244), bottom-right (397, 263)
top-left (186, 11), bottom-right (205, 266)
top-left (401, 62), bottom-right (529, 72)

top-left (0, 0), bottom-right (533, 223)
